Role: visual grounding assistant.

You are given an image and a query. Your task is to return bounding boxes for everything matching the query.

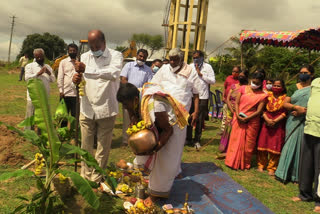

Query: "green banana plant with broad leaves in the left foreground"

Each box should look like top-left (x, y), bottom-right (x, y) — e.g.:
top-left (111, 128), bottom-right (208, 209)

top-left (0, 79), bottom-right (114, 213)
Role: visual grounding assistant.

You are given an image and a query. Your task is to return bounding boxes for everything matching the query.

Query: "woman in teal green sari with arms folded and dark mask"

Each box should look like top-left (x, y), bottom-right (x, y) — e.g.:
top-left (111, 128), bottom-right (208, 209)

top-left (275, 65), bottom-right (314, 182)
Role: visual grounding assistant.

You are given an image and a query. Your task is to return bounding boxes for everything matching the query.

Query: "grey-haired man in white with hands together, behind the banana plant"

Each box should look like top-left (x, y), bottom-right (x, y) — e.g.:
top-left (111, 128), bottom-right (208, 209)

top-left (25, 48), bottom-right (56, 129)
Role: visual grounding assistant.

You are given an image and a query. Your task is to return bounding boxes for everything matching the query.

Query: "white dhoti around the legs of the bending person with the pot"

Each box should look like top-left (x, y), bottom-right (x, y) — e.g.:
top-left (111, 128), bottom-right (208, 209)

top-left (134, 125), bottom-right (187, 197)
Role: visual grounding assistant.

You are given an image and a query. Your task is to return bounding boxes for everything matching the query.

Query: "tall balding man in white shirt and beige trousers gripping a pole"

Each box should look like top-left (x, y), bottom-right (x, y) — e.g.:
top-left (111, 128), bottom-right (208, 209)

top-left (72, 30), bottom-right (123, 183)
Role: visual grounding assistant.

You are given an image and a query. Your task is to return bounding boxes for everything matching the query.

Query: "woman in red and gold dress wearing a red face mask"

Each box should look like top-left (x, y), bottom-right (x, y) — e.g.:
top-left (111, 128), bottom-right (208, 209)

top-left (257, 79), bottom-right (286, 176)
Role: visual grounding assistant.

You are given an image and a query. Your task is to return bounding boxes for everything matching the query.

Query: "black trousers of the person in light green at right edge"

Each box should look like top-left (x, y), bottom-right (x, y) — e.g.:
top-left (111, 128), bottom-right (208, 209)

top-left (299, 134), bottom-right (320, 206)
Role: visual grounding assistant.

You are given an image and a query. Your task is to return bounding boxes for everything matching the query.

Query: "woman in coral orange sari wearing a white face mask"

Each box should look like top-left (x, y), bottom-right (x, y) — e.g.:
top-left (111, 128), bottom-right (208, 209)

top-left (225, 73), bottom-right (267, 170)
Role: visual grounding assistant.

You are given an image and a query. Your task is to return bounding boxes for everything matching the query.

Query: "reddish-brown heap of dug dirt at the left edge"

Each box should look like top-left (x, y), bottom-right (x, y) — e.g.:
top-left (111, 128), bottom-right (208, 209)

top-left (0, 116), bottom-right (28, 166)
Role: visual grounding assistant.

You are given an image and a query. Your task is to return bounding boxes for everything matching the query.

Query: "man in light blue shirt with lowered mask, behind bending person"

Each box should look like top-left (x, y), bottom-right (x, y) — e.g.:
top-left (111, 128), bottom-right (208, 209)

top-left (120, 49), bottom-right (153, 145)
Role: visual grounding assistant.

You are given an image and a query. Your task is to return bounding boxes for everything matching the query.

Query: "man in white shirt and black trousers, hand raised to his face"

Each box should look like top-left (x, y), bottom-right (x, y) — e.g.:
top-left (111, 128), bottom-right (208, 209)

top-left (187, 50), bottom-right (216, 149)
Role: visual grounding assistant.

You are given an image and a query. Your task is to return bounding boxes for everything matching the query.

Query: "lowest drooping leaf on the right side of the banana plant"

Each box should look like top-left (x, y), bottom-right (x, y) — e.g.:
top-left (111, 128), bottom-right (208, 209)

top-left (56, 170), bottom-right (100, 209)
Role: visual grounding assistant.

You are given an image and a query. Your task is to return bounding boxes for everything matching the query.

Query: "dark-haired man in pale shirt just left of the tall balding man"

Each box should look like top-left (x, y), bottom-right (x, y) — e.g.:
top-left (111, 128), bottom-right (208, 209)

top-left (57, 43), bottom-right (78, 127)
